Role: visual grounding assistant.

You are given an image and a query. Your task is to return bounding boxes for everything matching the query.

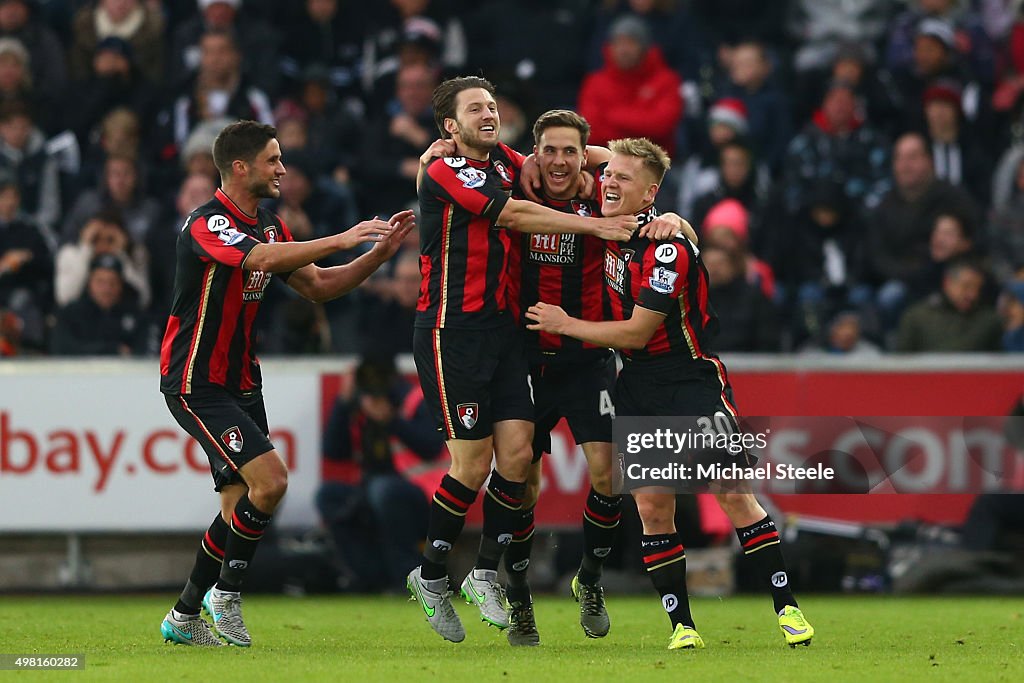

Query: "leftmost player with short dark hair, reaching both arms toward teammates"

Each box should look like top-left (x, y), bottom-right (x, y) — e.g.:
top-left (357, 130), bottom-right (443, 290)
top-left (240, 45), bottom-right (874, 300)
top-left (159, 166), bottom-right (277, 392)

top-left (160, 121), bottom-right (415, 647)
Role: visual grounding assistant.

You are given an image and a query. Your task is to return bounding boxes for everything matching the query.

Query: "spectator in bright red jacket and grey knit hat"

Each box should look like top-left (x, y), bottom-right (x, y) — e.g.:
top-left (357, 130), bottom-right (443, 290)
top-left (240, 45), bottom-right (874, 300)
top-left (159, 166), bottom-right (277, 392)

top-left (580, 15), bottom-right (683, 155)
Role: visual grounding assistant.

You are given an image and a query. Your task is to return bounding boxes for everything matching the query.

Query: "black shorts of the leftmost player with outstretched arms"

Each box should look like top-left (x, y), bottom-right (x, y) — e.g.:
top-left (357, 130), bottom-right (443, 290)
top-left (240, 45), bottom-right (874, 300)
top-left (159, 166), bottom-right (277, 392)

top-left (164, 389), bottom-right (273, 490)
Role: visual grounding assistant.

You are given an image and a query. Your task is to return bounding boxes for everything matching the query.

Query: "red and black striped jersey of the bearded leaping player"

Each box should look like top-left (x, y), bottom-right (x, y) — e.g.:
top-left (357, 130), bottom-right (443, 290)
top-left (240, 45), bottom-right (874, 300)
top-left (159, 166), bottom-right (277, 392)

top-left (416, 143), bottom-right (524, 330)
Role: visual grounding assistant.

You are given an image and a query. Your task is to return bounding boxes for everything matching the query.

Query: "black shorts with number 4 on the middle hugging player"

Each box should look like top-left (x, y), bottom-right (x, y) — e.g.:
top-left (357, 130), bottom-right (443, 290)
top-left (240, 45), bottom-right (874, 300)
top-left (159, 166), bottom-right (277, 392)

top-left (529, 353), bottom-right (615, 463)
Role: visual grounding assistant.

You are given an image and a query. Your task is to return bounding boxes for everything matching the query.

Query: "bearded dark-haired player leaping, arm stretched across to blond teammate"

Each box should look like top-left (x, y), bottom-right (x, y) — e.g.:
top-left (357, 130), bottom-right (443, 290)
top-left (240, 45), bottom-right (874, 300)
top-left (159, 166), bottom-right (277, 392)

top-left (407, 77), bottom-right (636, 642)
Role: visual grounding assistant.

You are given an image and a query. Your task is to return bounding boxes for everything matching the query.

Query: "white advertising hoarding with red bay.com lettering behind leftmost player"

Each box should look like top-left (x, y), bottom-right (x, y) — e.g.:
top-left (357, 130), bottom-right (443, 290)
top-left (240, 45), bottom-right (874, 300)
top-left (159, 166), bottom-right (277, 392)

top-left (0, 359), bottom-right (321, 531)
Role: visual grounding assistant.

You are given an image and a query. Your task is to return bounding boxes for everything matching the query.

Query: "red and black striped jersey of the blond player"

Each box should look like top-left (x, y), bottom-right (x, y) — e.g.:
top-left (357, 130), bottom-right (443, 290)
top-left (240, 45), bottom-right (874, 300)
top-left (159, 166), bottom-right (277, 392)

top-left (604, 207), bottom-right (718, 378)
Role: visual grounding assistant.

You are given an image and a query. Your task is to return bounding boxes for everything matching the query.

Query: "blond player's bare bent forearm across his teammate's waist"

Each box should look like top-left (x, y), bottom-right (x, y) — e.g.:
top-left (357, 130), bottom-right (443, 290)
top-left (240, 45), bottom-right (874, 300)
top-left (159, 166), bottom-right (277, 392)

top-left (526, 302), bottom-right (665, 349)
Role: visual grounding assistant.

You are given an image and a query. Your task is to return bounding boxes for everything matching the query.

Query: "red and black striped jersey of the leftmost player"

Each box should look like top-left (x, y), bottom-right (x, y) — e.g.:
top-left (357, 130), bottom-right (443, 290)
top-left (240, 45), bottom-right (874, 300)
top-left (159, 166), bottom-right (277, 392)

top-left (160, 189), bottom-right (292, 394)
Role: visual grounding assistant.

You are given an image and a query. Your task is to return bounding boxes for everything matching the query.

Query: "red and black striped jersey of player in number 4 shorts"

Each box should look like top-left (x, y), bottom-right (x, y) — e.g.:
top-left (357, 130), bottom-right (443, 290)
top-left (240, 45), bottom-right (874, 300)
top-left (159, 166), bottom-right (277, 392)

top-left (509, 200), bottom-right (607, 364)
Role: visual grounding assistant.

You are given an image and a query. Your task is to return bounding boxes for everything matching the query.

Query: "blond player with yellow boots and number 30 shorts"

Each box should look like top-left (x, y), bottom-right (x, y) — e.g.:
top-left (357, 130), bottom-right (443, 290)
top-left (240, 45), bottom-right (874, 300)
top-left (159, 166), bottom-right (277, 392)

top-left (526, 138), bottom-right (814, 649)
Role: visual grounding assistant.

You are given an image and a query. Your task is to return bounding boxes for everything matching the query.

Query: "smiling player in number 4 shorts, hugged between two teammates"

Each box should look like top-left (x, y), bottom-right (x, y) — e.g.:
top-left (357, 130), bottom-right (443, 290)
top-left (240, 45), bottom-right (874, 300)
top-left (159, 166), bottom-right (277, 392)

top-left (505, 110), bottom-right (696, 645)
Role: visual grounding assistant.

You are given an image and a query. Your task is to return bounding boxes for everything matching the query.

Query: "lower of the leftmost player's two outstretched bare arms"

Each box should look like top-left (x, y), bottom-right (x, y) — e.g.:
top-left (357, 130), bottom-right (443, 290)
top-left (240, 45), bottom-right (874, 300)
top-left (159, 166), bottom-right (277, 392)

top-left (288, 211), bottom-right (416, 303)
